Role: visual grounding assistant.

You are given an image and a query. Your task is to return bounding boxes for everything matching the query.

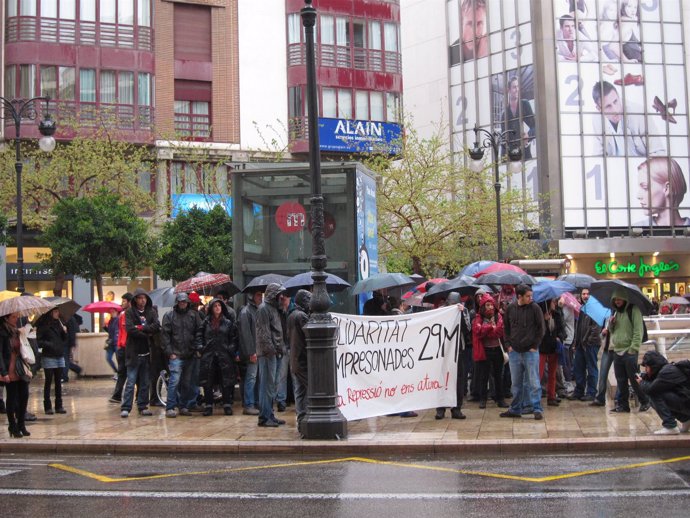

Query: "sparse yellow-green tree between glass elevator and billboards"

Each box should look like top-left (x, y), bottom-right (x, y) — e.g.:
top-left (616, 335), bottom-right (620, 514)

top-left (365, 125), bottom-right (538, 274)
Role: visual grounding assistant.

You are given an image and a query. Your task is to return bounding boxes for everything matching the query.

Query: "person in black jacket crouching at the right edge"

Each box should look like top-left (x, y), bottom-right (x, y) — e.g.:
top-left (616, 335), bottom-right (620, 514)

top-left (638, 351), bottom-right (690, 435)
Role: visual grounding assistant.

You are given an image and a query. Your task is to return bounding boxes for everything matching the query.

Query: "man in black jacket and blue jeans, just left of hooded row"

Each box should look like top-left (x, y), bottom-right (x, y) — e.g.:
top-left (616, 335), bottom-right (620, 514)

top-left (120, 288), bottom-right (161, 417)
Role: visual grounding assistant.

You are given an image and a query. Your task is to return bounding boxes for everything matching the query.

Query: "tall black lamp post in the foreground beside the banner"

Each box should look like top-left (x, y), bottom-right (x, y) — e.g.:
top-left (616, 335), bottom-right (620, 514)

top-left (299, 0), bottom-right (347, 439)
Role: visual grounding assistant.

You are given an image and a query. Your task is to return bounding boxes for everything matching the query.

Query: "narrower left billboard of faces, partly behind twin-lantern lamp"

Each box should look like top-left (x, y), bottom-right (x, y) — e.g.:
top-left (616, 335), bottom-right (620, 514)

top-left (447, 0), bottom-right (539, 226)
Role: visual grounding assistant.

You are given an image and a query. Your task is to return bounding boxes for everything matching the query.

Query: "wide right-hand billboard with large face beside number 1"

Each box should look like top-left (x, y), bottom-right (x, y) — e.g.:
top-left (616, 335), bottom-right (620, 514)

top-left (553, 0), bottom-right (690, 229)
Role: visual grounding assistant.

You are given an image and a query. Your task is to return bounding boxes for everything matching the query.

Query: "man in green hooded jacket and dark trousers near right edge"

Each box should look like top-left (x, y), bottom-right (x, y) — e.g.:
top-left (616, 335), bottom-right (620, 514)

top-left (609, 289), bottom-right (651, 413)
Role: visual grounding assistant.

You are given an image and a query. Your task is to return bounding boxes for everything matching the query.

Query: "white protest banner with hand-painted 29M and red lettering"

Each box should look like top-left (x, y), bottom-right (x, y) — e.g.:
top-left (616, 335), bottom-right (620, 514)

top-left (332, 306), bottom-right (462, 420)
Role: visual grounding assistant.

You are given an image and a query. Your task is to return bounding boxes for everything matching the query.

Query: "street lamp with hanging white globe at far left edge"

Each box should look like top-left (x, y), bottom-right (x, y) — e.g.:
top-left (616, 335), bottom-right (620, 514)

top-left (0, 97), bottom-right (56, 293)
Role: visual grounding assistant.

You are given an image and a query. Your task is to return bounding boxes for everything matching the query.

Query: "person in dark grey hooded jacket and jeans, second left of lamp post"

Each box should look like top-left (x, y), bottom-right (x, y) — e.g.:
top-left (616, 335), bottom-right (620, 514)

top-left (256, 283), bottom-right (285, 428)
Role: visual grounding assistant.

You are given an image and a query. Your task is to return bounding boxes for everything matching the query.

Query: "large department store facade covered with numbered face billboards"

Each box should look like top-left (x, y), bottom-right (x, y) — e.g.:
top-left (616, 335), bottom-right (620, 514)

top-left (401, 0), bottom-right (690, 296)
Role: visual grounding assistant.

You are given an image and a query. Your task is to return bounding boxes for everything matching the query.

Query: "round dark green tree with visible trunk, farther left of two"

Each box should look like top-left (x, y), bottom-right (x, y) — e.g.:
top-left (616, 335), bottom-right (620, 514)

top-left (41, 191), bottom-right (155, 300)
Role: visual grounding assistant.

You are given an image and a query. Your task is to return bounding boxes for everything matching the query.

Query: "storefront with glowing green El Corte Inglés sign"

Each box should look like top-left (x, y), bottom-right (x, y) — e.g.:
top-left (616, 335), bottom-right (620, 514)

top-left (559, 237), bottom-right (690, 300)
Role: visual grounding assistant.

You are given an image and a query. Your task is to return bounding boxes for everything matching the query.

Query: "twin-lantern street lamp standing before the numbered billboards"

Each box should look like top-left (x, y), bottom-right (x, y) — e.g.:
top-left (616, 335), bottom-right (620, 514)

top-left (469, 125), bottom-right (522, 262)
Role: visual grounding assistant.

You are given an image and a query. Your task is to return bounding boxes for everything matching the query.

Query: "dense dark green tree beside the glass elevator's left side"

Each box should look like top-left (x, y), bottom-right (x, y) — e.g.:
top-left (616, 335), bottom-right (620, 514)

top-left (155, 205), bottom-right (232, 281)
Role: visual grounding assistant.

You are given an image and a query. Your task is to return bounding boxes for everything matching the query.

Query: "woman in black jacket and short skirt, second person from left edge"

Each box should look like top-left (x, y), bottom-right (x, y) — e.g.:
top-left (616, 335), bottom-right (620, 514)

top-left (36, 308), bottom-right (67, 415)
